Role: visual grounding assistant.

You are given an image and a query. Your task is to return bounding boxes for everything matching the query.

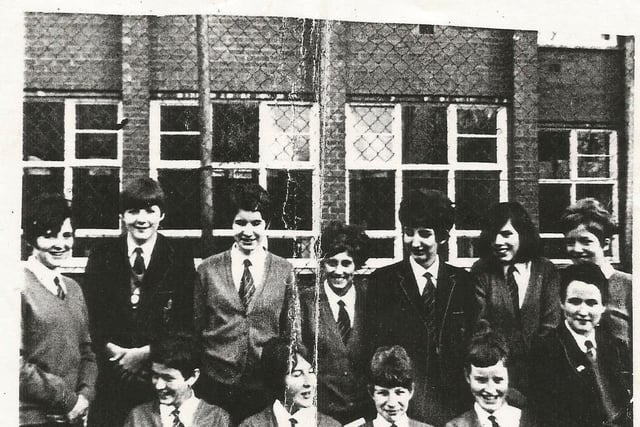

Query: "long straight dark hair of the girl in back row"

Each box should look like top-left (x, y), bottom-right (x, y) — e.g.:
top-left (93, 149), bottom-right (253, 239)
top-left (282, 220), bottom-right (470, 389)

top-left (478, 202), bottom-right (540, 262)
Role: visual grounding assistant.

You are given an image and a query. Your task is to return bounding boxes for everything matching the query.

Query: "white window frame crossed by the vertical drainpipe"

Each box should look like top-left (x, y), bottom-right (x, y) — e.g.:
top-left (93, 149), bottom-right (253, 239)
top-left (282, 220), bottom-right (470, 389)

top-left (149, 99), bottom-right (320, 268)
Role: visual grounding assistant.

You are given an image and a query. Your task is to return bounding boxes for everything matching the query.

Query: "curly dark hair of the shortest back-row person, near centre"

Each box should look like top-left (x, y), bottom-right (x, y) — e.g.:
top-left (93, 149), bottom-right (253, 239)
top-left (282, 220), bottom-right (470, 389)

top-left (320, 221), bottom-right (369, 268)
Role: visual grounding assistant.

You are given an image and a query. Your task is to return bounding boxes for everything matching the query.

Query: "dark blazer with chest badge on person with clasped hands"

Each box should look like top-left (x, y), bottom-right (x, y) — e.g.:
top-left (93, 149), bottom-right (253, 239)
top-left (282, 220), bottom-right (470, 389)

top-left (84, 234), bottom-right (195, 359)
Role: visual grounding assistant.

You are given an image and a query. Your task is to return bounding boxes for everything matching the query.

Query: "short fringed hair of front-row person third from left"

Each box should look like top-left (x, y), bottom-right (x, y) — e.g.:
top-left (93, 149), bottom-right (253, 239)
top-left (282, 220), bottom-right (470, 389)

top-left (369, 345), bottom-right (414, 393)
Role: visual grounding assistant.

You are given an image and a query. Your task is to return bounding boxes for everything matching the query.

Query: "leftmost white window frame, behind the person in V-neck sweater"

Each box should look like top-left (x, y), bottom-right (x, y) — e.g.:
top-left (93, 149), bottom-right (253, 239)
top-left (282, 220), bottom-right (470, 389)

top-left (22, 97), bottom-right (123, 273)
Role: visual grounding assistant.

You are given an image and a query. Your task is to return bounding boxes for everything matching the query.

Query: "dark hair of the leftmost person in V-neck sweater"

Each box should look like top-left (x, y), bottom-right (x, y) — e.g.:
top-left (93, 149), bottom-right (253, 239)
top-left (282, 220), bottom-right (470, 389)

top-left (23, 193), bottom-right (71, 246)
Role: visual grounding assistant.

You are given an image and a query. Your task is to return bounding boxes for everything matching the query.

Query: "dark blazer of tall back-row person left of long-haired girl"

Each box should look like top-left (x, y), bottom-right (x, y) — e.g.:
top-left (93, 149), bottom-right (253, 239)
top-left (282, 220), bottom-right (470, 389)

top-left (365, 260), bottom-right (476, 425)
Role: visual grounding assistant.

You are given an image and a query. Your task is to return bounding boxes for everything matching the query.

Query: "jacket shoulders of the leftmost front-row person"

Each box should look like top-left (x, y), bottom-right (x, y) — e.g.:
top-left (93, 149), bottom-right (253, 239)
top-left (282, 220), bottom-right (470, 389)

top-left (124, 400), bottom-right (233, 427)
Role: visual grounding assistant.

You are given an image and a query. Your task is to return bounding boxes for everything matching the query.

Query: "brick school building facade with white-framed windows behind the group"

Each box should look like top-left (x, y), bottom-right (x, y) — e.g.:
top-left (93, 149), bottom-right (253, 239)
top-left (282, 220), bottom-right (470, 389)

top-left (22, 13), bottom-right (634, 274)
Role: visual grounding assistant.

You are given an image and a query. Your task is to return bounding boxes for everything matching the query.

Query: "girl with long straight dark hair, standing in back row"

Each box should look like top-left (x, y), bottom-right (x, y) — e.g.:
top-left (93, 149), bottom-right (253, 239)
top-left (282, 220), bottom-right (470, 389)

top-left (471, 202), bottom-right (560, 395)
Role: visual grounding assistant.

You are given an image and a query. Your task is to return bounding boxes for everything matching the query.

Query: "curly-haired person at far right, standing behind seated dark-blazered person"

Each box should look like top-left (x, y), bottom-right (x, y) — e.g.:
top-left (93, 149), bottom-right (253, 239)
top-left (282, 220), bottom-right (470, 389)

top-left (560, 197), bottom-right (633, 343)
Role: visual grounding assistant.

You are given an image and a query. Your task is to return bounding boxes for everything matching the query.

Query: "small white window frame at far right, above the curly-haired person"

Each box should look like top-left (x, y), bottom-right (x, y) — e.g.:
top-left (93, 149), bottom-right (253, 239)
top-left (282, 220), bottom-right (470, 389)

top-left (538, 127), bottom-right (620, 264)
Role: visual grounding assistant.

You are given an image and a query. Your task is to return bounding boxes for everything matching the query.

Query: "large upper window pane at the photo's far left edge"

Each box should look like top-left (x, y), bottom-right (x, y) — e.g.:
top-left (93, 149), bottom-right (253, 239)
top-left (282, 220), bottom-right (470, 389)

top-left (22, 102), bottom-right (64, 160)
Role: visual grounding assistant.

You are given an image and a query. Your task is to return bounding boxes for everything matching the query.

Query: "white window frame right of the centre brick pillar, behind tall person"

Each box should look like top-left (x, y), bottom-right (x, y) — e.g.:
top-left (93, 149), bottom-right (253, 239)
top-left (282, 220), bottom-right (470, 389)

top-left (345, 102), bottom-right (509, 270)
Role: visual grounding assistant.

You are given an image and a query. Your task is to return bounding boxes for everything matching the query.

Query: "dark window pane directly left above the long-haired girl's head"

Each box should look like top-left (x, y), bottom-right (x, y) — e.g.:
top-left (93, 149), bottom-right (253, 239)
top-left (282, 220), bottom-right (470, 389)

top-left (455, 171), bottom-right (500, 230)
